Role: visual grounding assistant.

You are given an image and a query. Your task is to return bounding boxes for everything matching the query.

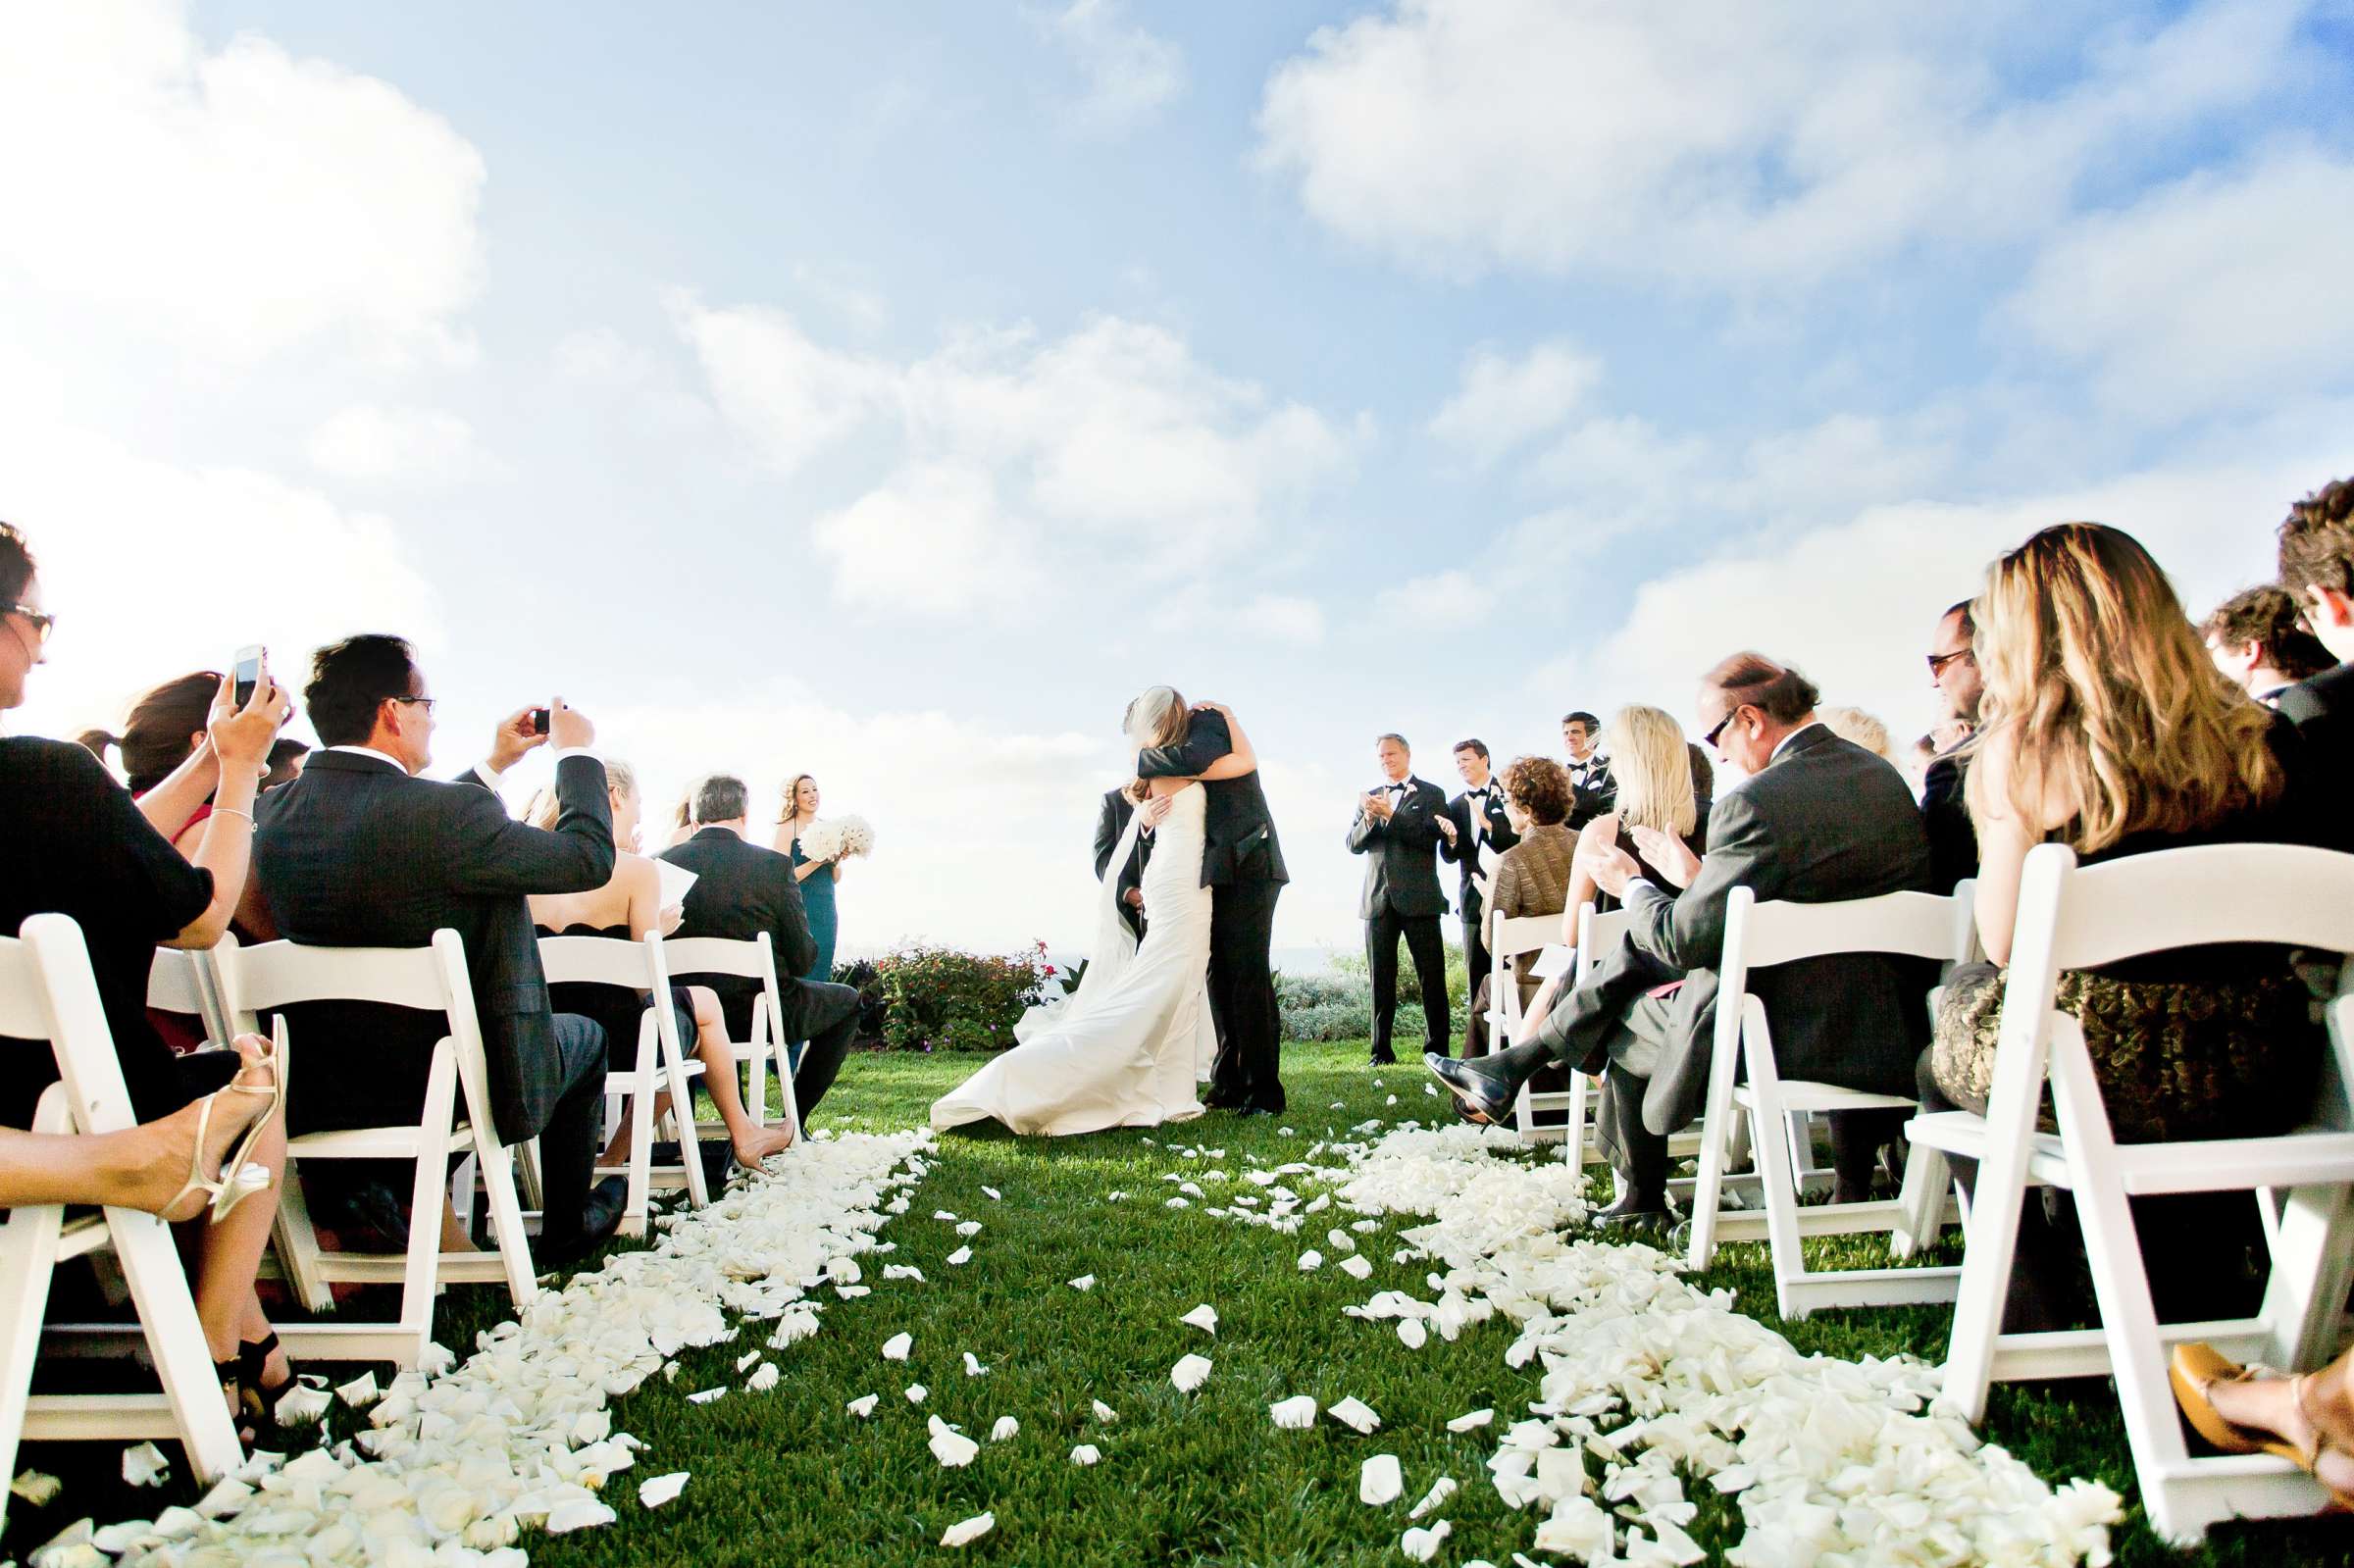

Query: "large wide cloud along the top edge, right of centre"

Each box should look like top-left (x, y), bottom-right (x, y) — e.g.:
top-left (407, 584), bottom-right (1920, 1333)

top-left (1259, 0), bottom-right (2307, 289)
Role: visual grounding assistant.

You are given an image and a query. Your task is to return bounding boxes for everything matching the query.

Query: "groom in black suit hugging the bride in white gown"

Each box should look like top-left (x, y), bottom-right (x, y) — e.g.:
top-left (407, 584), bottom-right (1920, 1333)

top-left (1137, 704), bottom-right (1290, 1116)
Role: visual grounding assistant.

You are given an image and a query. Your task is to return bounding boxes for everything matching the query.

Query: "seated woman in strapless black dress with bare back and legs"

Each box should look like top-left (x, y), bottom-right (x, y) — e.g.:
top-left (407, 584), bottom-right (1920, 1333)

top-left (525, 758), bottom-right (793, 1170)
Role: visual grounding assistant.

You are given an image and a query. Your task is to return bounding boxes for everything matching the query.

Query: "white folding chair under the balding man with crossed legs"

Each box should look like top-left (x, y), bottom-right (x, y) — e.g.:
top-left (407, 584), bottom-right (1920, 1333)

top-left (1688, 887), bottom-right (1970, 1319)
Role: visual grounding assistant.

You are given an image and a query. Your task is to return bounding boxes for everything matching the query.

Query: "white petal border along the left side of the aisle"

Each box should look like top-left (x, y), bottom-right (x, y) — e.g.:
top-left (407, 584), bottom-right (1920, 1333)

top-left (118, 1130), bottom-right (935, 1568)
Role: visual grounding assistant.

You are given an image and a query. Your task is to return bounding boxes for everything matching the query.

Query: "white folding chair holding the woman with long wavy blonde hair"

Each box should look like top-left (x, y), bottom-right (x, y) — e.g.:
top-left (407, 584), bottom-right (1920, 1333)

top-left (1909, 845), bottom-right (2354, 1544)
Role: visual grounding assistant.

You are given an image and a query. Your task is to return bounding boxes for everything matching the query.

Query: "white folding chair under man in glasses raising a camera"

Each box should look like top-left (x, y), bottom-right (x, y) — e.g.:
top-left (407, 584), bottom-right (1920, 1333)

top-left (217, 930), bottom-right (539, 1368)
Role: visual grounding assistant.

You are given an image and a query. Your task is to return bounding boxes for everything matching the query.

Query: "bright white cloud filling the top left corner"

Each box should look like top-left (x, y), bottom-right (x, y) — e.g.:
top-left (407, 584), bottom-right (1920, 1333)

top-left (0, 0), bottom-right (485, 363)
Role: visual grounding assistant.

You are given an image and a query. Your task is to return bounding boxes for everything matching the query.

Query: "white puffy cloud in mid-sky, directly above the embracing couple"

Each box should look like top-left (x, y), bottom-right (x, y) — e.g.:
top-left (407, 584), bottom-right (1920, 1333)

top-left (678, 301), bottom-right (1354, 612)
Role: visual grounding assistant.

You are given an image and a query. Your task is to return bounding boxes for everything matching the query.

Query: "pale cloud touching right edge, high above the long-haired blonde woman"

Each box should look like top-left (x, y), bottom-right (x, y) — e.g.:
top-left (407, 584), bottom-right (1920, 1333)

top-left (2003, 146), bottom-right (2354, 419)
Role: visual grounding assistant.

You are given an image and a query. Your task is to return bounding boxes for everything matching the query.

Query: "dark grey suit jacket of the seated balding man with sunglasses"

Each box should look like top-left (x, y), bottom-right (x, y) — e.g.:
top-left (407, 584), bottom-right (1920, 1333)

top-left (1582, 725), bottom-right (1937, 1133)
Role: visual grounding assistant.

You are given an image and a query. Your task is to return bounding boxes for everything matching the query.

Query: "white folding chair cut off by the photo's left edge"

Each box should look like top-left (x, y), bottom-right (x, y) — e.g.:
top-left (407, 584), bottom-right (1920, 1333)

top-left (0, 914), bottom-right (245, 1521)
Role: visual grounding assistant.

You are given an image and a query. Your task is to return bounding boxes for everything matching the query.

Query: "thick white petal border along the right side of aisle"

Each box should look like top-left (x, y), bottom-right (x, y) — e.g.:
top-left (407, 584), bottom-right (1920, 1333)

top-left (1330, 1128), bottom-right (2124, 1568)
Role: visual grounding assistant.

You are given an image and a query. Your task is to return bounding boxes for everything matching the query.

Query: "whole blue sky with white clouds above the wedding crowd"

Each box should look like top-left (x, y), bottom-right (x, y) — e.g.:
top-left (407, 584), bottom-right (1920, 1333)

top-left (0, 0), bottom-right (2354, 946)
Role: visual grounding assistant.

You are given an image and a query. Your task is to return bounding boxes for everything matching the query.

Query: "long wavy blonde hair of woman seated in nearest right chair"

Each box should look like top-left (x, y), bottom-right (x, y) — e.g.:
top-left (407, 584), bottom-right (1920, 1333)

top-left (1968, 523), bottom-right (2283, 852)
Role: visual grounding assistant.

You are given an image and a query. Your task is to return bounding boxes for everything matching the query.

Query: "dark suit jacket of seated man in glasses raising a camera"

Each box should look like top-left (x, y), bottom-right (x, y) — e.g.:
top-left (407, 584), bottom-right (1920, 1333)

top-left (254, 751), bottom-right (614, 1144)
